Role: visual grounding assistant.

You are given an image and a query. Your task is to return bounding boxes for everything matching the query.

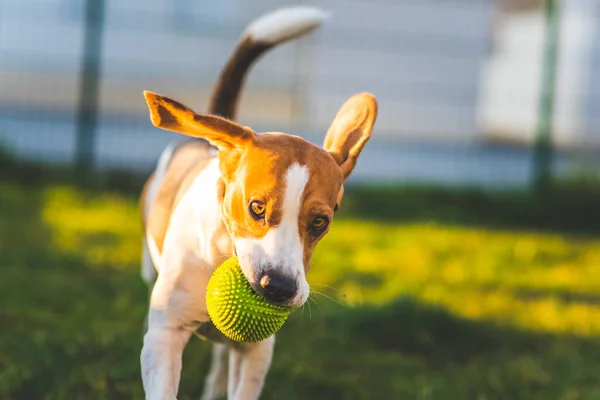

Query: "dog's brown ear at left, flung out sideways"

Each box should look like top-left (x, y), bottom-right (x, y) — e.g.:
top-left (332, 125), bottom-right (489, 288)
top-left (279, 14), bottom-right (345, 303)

top-left (144, 91), bottom-right (255, 150)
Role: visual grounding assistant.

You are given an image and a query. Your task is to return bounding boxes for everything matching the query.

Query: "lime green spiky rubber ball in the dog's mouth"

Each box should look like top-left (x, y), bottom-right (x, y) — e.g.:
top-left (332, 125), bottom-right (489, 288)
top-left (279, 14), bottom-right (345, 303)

top-left (206, 257), bottom-right (290, 343)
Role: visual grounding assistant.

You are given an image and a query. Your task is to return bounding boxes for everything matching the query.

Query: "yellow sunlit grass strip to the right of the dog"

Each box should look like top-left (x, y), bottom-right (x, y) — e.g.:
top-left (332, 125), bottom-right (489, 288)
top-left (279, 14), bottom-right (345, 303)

top-left (309, 220), bottom-right (600, 335)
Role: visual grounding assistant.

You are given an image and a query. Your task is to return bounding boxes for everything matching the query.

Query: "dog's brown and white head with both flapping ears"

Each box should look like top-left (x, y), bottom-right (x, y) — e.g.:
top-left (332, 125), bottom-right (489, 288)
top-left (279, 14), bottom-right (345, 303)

top-left (144, 92), bottom-right (377, 307)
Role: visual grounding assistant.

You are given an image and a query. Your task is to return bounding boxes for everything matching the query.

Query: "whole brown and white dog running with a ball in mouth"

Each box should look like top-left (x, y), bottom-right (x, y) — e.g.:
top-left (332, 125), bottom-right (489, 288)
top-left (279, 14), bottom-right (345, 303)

top-left (141, 7), bottom-right (377, 399)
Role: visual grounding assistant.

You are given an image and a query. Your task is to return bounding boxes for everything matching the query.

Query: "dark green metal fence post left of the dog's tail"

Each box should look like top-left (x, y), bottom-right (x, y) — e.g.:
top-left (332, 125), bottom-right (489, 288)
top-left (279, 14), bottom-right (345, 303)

top-left (75, 0), bottom-right (105, 171)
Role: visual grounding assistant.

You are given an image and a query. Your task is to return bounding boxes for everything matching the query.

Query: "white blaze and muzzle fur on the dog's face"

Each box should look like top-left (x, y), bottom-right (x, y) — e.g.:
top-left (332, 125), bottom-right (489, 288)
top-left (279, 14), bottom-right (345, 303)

top-left (235, 164), bottom-right (309, 305)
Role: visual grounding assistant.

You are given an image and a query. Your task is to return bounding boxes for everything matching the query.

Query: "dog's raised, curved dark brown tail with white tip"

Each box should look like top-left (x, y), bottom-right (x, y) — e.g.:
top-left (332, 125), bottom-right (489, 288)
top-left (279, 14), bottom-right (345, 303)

top-left (208, 6), bottom-right (326, 120)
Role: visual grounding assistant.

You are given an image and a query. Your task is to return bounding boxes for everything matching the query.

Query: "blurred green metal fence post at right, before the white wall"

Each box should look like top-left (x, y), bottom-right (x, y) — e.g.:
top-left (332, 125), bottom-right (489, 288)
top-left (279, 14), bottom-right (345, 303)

top-left (533, 0), bottom-right (560, 193)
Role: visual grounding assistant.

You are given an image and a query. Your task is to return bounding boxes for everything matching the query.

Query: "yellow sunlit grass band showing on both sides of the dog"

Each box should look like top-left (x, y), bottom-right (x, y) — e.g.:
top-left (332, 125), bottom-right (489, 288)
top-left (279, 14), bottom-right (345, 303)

top-left (38, 187), bottom-right (600, 335)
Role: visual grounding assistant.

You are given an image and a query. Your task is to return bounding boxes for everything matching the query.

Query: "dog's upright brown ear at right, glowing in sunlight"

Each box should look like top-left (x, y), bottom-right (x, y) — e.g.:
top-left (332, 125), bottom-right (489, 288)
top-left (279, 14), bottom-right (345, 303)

top-left (323, 93), bottom-right (377, 179)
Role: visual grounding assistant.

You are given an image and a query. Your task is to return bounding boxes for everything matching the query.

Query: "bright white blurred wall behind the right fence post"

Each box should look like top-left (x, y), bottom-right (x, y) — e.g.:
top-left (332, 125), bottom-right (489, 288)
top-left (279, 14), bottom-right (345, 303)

top-left (479, 0), bottom-right (598, 145)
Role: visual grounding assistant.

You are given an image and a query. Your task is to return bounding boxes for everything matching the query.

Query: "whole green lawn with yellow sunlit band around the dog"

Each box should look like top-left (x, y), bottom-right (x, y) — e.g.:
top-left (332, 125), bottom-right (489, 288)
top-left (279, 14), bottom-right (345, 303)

top-left (0, 174), bottom-right (600, 400)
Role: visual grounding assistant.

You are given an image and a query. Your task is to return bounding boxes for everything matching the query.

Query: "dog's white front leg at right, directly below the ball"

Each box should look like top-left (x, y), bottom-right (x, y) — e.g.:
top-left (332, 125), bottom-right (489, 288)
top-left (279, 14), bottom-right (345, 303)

top-left (227, 336), bottom-right (275, 400)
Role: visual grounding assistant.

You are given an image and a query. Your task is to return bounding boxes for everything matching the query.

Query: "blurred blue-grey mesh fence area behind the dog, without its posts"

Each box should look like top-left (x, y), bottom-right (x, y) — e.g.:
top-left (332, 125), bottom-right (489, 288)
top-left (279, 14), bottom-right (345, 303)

top-left (0, 0), bottom-right (600, 186)
